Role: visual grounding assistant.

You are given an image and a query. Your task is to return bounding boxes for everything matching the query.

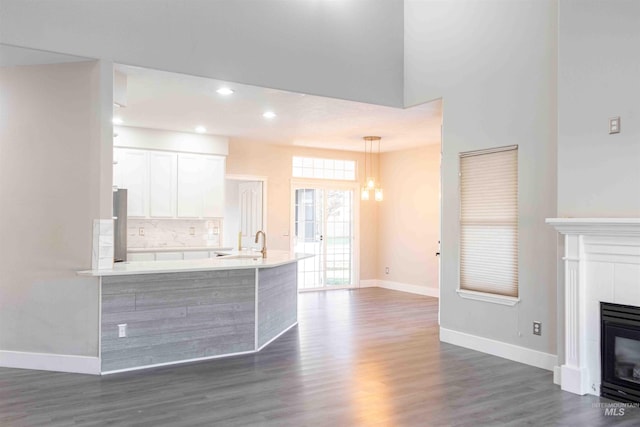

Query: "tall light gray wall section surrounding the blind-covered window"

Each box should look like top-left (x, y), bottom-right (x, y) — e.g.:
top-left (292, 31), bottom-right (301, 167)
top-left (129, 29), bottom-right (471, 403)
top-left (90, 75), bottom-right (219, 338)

top-left (405, 0), bottom-right (557, 354)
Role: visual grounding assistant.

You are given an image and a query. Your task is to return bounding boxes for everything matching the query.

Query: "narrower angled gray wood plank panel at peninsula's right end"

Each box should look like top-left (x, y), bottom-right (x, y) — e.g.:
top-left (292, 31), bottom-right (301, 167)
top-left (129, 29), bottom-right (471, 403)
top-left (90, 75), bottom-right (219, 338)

top-left (257, 264), bottom-right (298, 348)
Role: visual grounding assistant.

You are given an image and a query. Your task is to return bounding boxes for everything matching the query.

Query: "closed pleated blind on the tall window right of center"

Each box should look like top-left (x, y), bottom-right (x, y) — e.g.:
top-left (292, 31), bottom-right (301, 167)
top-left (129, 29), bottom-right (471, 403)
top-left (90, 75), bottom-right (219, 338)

top-left (460, 146), bottom-right (518, 297)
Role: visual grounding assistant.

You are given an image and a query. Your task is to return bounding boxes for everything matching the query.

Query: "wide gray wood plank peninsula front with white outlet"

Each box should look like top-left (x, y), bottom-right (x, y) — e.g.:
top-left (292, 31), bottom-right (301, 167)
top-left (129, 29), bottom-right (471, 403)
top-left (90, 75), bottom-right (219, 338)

top-left (101, 269), bottom-right (256, 372)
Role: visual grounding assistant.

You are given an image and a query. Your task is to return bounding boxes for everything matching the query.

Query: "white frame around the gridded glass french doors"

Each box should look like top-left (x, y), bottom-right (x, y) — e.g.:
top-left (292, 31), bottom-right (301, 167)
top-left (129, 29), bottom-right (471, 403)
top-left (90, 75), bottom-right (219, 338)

top-left (289, 178), bottom-right (360, 292)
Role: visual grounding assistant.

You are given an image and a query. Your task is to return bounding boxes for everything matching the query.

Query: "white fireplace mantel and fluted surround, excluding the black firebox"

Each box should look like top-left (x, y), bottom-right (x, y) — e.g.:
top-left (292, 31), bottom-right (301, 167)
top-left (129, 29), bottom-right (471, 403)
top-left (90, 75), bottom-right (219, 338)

top-left (546, 218), bottom-right (640, 395)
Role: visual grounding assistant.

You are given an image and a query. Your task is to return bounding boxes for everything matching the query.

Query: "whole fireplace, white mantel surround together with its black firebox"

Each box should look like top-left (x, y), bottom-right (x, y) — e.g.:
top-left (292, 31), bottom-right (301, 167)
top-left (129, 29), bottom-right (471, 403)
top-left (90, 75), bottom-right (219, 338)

top-left (546, 218), bottom-right (640, 402)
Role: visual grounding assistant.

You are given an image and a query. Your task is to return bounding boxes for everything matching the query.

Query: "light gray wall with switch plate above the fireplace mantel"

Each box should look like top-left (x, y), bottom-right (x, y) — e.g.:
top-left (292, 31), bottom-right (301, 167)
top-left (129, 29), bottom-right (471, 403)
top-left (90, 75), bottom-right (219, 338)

top-left (558, 0), bottom-right (640, 217)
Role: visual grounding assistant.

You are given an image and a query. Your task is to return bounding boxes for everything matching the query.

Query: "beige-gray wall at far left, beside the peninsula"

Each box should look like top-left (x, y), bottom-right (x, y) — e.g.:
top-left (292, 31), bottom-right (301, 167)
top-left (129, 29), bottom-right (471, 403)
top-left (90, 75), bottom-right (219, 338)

top-left (0, 62), bottom-right (102, 356)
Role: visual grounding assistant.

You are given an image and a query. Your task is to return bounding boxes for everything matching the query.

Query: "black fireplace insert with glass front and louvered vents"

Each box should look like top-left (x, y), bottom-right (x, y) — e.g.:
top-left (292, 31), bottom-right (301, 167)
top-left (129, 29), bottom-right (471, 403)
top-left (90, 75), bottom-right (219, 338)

top-left (600, 303), bottom-right (640, 403)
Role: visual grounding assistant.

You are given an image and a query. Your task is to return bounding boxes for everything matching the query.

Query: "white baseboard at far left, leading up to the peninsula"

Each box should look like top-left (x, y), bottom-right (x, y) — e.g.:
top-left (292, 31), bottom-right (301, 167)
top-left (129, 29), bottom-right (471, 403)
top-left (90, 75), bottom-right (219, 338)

top-left (0, 350), bottom-right (100, 375)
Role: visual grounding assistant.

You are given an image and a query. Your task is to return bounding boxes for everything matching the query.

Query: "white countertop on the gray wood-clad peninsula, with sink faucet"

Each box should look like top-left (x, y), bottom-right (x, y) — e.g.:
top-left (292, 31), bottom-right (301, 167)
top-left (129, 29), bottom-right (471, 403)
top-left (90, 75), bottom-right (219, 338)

top-left (78, 251), bottom-right (314, 276)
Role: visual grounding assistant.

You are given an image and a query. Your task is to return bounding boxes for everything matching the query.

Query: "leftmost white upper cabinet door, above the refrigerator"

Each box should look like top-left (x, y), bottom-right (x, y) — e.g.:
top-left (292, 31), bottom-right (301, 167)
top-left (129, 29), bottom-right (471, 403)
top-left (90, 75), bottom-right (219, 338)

top-left (114, 148), bottom-right (149, 218)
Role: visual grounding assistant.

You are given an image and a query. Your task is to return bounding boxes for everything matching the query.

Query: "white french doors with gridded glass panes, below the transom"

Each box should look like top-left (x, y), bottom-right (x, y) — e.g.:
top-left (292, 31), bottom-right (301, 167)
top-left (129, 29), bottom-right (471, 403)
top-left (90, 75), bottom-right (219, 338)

top-left (291, 183), bottom-right (358, 290)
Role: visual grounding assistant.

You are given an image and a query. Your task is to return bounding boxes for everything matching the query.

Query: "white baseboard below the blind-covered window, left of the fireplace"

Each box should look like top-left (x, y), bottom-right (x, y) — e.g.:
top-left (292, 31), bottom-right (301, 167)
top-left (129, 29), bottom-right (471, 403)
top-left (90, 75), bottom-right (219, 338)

top-left (440, 327), bottom-right (558, 371)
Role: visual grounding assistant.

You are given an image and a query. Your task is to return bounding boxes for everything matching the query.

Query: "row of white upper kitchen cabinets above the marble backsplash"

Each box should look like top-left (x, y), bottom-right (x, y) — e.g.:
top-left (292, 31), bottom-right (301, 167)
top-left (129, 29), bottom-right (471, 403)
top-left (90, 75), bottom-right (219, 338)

top-left (113, 148), bottom-right (225, 218)
